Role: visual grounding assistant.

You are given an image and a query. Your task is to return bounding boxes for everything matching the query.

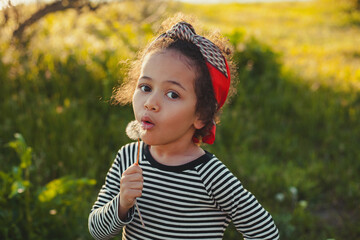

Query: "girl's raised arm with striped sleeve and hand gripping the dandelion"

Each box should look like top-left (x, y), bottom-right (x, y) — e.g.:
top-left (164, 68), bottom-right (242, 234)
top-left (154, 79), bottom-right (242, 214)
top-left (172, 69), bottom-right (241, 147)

top-left (88, 147), bottom-right (142, 239)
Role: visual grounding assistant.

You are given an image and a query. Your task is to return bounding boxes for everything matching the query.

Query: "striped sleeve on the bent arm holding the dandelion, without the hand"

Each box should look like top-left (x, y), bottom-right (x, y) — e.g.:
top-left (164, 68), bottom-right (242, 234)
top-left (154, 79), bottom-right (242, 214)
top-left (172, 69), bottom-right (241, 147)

top-left (88, 148), bottom-right (134, 240)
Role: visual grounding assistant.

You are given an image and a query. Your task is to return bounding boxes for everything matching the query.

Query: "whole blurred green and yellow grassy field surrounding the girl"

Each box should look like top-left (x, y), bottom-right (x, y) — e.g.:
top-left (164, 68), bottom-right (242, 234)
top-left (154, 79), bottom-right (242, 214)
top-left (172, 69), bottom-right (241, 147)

top-left (0, 0), bottom-right (360, 240)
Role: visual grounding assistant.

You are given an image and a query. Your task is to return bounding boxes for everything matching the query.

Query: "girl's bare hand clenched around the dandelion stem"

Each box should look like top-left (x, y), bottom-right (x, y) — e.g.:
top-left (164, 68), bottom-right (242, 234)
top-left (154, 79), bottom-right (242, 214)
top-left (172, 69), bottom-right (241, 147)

top-left (119, 164), bottom-right (144, 220)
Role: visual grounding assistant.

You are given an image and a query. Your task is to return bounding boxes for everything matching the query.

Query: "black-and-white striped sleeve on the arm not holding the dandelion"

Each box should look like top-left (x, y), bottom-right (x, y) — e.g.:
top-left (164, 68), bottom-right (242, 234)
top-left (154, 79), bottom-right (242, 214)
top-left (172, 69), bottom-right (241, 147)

top-left (201, 157), bottom-right (279, 239)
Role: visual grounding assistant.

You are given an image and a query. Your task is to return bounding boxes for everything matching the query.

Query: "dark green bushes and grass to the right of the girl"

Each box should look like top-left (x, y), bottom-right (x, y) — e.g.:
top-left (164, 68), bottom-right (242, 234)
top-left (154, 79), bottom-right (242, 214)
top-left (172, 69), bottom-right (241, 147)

top-left (209, 33), bottom-right (360, 239)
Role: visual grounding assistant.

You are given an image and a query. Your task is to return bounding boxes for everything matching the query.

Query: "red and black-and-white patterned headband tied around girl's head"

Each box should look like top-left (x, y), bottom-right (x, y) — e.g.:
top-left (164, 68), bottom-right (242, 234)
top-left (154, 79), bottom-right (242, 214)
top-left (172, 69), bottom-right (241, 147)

top-left (158, 22), bottom-right (230, 144)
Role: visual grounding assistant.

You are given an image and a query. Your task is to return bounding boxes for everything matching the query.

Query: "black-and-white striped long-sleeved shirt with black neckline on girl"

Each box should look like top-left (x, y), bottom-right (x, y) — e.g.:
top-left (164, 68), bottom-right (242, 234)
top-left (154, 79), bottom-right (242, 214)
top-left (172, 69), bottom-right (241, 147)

top-left (89, 142), bottom-right (279, 240)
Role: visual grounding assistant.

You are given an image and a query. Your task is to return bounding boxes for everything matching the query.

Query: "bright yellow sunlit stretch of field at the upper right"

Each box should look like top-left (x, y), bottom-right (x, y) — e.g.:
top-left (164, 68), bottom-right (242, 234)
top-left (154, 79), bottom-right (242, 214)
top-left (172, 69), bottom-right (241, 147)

top-left (184, 1), bottom-right (360, 91)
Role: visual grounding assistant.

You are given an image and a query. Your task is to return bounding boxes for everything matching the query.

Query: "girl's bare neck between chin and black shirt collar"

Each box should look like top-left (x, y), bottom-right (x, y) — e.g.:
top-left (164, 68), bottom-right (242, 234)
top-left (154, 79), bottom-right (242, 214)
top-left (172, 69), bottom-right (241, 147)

top-left (149, 141), bottom-right (205, 166)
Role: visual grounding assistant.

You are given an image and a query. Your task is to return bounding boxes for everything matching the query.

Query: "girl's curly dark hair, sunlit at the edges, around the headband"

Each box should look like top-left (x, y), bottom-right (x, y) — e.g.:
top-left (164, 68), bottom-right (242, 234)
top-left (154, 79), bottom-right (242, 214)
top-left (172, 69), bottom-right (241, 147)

top-left (112, 16), bottom-right (235, 140)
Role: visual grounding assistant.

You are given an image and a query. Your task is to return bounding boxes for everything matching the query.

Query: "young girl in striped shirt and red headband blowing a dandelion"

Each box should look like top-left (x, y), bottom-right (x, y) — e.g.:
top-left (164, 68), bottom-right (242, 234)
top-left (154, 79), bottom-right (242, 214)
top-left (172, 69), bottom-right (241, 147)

top-left (89, 15), bottom-right (279, 239)
